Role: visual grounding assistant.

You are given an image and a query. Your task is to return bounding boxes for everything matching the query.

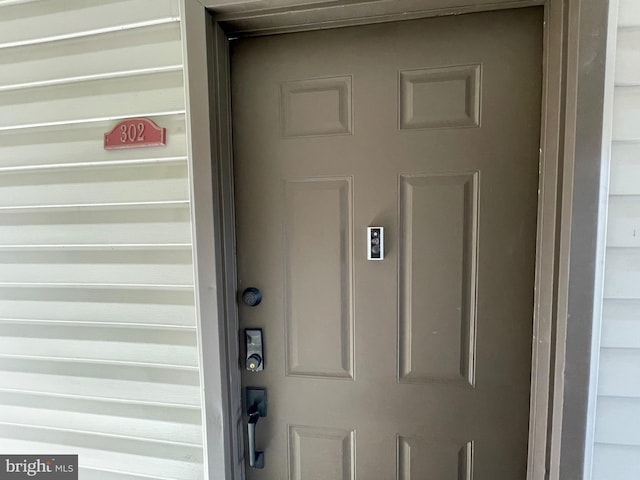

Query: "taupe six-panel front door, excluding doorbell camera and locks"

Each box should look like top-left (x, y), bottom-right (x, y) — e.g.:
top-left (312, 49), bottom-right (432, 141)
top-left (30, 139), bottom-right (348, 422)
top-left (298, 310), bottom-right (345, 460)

top-left (232, 8), bottom-right (542, 480)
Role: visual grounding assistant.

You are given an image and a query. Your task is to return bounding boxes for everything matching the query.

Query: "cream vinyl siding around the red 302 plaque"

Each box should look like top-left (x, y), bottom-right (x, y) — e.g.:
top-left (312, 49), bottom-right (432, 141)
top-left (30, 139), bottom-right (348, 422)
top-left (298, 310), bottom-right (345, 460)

top-left (0, 0), bottom-right (204, 480)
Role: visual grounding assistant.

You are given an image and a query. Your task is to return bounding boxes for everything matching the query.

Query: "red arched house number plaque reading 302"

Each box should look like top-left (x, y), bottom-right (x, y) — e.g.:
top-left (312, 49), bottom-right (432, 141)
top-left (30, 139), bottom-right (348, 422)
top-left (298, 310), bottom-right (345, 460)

top-left (104, 118), bottom-right (167, 150)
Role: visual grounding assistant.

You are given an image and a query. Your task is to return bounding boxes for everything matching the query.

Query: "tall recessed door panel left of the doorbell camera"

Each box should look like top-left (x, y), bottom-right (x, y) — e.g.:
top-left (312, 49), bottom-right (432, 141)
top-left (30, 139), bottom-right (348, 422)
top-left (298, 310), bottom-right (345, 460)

top-left (284, 178), bottom-right (353, 378)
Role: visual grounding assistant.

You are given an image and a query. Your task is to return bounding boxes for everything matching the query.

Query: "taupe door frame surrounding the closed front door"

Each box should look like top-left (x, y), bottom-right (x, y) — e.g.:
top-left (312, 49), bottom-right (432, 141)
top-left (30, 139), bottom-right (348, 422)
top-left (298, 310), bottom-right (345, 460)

top-left (180, 0), bottom-right (615, 480)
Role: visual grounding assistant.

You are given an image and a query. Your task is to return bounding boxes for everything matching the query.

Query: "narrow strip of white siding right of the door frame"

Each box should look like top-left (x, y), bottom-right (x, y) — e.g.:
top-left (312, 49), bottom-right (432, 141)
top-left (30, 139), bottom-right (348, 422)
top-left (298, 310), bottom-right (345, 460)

top-left (592, 0), bottom-right (640, 480)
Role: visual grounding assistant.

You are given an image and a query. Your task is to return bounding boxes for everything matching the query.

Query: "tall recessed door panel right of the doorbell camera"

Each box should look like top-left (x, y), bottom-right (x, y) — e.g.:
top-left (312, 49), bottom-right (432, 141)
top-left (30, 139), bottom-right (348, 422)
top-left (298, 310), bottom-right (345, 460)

top-left (399, 172), bottom-right (479, 385)
